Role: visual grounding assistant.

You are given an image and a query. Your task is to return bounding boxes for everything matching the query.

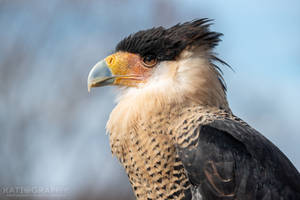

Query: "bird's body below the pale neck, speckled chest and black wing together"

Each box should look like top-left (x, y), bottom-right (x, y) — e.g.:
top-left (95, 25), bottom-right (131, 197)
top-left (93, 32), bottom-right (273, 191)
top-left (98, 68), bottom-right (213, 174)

top-left (111, 105), bottom-right (300, 200)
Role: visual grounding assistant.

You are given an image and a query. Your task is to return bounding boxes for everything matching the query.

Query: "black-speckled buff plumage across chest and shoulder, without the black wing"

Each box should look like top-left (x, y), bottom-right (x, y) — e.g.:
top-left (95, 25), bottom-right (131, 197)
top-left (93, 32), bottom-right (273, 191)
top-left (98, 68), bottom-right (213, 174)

top-left (111, 105), bottom-right (244, 199)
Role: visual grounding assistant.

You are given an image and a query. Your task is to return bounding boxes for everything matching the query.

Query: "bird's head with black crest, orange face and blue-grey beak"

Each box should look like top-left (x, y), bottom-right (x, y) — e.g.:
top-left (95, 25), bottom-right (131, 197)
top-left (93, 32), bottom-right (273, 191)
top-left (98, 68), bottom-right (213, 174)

top-left (88, 19), bottom-right (227, 110)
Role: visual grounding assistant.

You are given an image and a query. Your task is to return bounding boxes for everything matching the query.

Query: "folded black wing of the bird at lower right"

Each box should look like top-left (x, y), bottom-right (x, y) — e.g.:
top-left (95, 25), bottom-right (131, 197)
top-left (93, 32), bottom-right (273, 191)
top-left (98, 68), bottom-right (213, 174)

top-left (177, 120), bottom-right (300, 200)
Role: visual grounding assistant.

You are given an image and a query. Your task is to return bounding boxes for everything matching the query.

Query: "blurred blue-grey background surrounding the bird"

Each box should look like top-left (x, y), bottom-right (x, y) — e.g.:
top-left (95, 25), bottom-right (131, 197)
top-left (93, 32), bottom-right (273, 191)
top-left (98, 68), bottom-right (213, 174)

top-left (0, 0), bottom-right (300, 199)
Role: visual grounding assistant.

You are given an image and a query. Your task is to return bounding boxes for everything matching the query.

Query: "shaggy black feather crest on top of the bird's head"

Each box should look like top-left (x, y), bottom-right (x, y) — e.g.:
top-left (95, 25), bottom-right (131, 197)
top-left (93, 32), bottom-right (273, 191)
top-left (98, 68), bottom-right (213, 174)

top-left (116, 18), bottom-right (222, 61)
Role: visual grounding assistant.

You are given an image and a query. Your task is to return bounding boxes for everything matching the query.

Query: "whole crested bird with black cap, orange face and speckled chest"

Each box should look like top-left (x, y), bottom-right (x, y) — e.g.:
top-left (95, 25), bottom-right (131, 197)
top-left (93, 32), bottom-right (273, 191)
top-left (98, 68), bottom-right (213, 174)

top-left (87, 18), bottom-right (300, 200)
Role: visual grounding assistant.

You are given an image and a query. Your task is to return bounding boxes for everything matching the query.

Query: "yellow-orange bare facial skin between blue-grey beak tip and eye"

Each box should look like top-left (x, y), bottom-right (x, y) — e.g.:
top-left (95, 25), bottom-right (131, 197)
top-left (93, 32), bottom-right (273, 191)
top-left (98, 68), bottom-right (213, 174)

top-left (105, 52), bottom-right (153, 87)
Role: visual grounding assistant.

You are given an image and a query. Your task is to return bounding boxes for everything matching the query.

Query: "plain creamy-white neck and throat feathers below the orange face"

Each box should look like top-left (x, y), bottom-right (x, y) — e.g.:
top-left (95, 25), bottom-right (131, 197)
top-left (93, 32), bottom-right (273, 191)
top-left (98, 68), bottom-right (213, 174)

top-left (107, 51), bottom-right (230, 138)
